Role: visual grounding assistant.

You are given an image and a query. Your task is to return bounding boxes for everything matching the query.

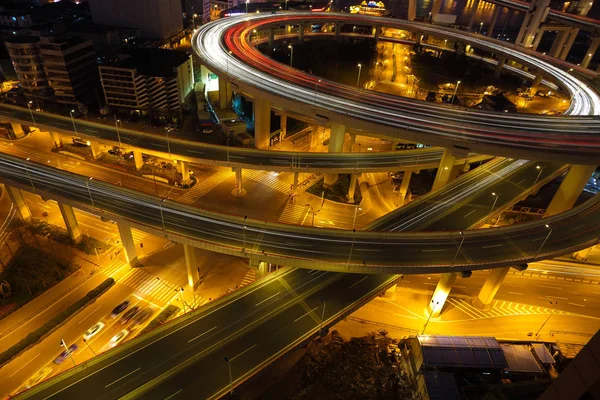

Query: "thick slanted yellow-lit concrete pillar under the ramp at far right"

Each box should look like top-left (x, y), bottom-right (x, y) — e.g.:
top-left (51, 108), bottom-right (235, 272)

top-left (544, 165), bottom-right (596, 218)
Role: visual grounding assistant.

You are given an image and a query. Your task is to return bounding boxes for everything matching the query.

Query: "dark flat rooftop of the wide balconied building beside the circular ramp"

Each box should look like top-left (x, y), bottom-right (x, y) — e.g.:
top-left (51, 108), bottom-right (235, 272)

top-left (104, 48), bottom-right (190, 77)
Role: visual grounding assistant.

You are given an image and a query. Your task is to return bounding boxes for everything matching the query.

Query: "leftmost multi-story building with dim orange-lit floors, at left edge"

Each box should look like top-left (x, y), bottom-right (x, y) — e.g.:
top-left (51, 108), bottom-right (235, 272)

top-left (4, 36), bottom-right (49, 96)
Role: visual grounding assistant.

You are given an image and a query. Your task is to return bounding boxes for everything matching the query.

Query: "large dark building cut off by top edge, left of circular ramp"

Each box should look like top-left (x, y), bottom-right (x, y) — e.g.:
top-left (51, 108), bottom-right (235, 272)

top-left (89, 0), bottom-right (183, 40)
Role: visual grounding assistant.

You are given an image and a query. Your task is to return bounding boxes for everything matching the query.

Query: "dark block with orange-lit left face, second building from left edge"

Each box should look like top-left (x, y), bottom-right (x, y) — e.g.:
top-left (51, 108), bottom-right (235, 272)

top-left (40, 37), bottom-right (98, 104)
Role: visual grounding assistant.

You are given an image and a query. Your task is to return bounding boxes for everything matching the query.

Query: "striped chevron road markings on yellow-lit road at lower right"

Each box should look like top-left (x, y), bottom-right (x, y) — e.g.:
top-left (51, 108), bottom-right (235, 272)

top-left (446, 297), bottom-right (570, 319)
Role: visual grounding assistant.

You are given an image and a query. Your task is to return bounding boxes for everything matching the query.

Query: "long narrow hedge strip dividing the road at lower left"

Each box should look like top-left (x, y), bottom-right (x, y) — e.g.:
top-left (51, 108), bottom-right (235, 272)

top-left (0, 278), bottom-right (115, 366)
